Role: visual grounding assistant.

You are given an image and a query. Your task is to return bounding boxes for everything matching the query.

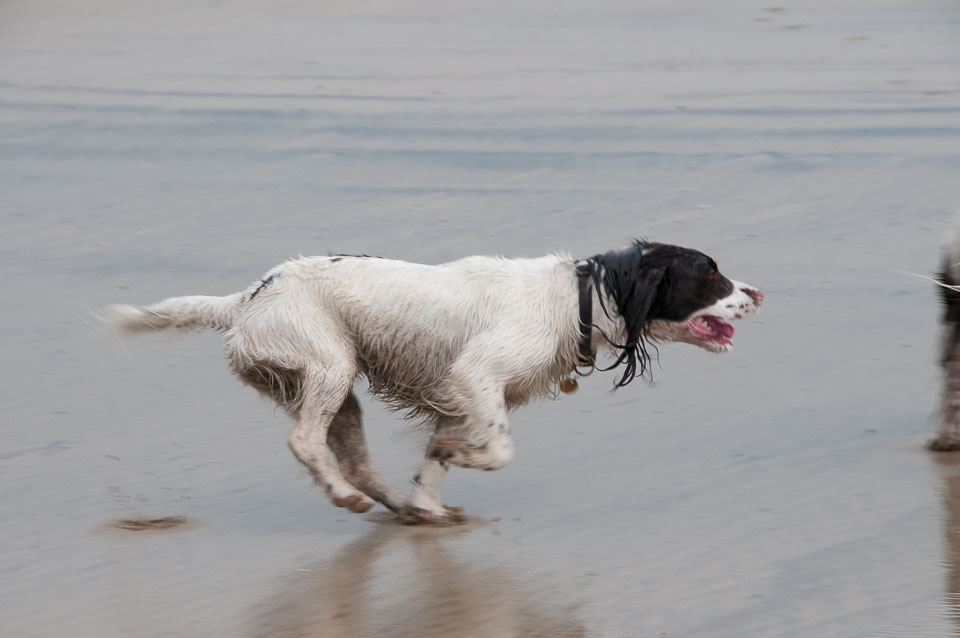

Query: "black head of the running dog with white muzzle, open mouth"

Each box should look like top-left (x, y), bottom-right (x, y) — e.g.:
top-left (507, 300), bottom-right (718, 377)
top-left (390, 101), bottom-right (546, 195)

top-left (594, 241), bottom-right (763, 386)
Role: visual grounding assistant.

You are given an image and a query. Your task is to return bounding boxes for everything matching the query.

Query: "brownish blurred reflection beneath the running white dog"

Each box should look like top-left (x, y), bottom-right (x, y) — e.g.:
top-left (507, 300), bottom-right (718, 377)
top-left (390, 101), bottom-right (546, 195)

top-left (254, 521), bottom-right (587, 638)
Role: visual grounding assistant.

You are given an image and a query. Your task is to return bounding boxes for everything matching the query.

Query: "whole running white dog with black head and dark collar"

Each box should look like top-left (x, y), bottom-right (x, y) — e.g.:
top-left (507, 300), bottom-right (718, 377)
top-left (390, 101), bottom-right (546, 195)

top-left (105, 241), bottom-right (763, 522)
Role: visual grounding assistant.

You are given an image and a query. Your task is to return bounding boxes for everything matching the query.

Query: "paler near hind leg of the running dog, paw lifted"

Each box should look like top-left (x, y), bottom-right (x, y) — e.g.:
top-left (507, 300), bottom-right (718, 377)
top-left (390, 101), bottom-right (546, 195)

top-left (287, 369), bottom-right (373, 513)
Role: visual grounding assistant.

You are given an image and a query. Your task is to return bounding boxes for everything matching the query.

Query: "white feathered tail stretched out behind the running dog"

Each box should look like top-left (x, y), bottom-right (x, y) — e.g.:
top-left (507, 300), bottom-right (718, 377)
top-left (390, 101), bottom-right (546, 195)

top-left (100, 293), bottom-right (243, 336)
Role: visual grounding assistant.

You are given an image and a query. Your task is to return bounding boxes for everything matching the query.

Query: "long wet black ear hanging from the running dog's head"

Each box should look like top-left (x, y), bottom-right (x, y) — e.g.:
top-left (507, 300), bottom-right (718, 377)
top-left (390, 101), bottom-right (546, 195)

top-left (595, 242), bottom-right (667, 388)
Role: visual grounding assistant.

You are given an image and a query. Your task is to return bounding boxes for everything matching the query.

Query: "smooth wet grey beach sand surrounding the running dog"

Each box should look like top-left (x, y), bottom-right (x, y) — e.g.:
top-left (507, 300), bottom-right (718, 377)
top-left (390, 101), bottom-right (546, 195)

top-left (0, 0), bottom-right (960, 638)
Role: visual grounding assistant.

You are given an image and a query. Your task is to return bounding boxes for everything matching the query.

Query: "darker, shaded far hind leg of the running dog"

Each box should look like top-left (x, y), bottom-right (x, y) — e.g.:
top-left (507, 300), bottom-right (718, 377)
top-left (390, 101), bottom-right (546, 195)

top-left (327, 392), bottom-right (410, 512)
